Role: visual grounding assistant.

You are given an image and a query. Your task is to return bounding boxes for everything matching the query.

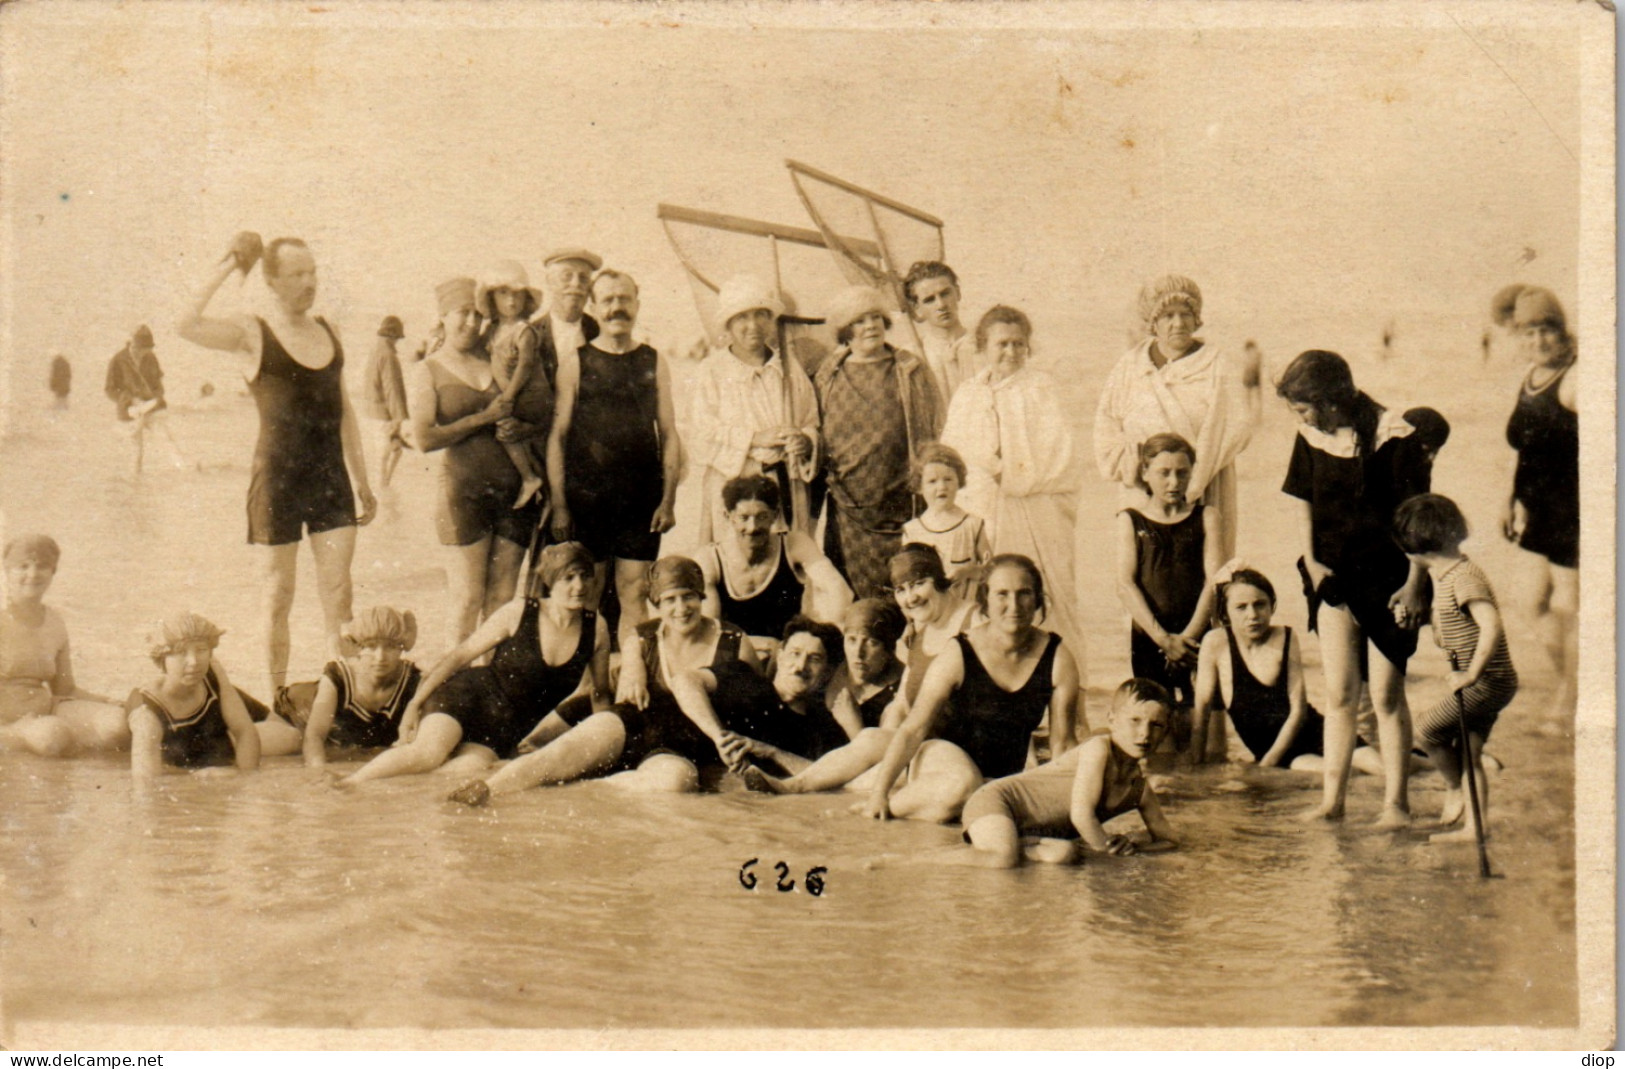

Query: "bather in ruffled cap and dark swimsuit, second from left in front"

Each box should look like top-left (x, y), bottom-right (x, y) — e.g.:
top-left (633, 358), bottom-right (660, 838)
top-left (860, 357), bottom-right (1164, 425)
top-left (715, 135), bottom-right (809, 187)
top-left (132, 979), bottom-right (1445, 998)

top-left (125, 612), bottom-right (268, 780)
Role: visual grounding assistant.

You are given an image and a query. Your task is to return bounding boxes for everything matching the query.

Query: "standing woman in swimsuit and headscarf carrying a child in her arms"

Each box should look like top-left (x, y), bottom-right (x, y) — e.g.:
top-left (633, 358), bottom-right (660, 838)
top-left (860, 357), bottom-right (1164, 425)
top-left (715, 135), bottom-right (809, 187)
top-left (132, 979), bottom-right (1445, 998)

top-left (406, 278), bottom-right (548, 642)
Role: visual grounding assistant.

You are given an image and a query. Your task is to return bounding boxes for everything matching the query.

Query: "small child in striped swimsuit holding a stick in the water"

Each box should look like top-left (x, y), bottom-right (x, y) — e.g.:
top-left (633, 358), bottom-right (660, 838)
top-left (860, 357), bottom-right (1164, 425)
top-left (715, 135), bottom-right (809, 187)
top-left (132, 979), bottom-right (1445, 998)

top-left (1394, 494), bottom-right (1518, 842)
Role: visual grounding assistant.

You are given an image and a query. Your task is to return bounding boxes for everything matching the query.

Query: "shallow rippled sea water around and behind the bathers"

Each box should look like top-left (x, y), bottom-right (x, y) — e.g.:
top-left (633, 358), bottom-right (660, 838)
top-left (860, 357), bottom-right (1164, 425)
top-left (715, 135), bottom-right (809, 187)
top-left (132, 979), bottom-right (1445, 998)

top-left (0, 326), bottom-right (1578, 1028)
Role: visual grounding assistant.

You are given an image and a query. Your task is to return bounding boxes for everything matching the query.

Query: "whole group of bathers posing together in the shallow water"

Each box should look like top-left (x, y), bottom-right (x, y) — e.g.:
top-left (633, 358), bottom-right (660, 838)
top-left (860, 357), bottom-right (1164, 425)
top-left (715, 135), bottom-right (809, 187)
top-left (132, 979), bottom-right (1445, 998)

top-left (0, 234), bottom-right (1578, 866)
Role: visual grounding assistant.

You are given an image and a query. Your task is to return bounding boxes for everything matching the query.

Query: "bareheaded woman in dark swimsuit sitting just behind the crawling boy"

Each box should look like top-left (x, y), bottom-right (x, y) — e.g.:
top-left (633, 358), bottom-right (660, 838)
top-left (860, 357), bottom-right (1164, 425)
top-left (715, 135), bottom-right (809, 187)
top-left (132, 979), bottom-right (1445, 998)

top-left (863, 554), bottom-right (1079, 824)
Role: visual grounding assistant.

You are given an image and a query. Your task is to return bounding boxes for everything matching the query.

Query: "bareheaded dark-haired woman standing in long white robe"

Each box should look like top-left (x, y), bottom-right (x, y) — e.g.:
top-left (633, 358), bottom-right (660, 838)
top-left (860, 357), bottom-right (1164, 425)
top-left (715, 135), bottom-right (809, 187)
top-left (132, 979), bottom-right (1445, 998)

top-left (943, 304), bottom-right (1087, 682)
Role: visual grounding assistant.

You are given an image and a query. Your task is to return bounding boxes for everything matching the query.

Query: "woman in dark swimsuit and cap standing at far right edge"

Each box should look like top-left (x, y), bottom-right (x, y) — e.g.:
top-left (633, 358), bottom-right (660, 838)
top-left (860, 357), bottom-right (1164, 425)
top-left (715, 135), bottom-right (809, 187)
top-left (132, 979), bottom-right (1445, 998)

top-left (1493, 286), bottom-right (1580, 707)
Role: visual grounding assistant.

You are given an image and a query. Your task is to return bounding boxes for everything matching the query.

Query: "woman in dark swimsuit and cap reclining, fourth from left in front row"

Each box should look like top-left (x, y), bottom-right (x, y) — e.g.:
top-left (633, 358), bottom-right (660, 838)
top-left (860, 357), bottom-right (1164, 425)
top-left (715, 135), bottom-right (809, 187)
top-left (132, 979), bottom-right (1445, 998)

top-left (341, 543), bottom-right (609, 785)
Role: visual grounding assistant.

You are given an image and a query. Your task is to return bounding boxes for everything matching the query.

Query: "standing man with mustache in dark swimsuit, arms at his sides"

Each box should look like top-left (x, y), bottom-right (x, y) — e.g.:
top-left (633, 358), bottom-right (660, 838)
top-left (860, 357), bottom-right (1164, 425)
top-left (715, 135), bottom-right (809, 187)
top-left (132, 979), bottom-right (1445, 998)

top-left (548, 270), bottom-right (679, 648)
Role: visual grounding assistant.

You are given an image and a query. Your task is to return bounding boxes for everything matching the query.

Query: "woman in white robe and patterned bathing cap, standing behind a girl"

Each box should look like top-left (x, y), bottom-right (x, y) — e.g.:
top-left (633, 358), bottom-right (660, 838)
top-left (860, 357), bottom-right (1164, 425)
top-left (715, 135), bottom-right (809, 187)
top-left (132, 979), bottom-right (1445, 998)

top-left (1095, 275), bottom-right (1263, 560)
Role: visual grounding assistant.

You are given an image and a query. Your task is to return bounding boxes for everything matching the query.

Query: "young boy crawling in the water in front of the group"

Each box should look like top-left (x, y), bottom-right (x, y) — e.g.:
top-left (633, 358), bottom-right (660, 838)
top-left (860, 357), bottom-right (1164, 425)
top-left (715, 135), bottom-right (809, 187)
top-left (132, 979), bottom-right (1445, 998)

top-left (952, 679), bottom-right (1175, 869)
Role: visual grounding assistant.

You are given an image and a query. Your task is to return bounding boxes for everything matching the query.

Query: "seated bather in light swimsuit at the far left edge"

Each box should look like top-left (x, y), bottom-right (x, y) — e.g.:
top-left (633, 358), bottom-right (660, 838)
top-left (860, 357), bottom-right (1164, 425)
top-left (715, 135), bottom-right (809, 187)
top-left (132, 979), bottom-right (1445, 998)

top-left (0, 535), bottom-right (130, 757)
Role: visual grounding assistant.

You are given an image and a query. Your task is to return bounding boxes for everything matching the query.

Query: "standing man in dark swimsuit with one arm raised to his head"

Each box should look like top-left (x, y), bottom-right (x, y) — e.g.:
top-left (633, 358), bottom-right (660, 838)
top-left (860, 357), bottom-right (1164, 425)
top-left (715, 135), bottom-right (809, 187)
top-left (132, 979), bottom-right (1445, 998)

top-left (176, 232), bottom-right (377, 697)
